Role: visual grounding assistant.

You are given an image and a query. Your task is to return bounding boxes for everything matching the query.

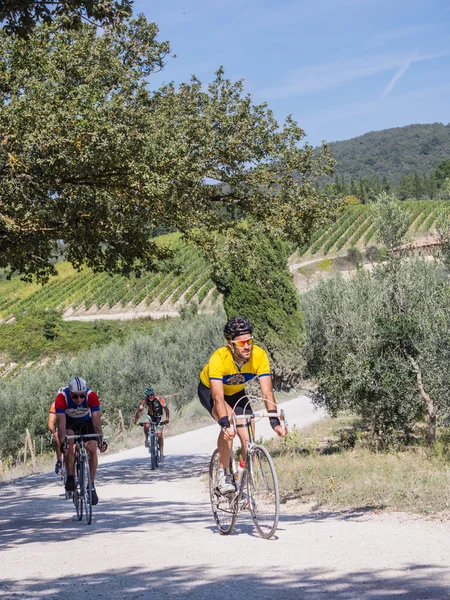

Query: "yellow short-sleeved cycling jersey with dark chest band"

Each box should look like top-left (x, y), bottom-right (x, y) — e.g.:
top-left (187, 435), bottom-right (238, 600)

top-left (200, 346), bottom-right (270, 396)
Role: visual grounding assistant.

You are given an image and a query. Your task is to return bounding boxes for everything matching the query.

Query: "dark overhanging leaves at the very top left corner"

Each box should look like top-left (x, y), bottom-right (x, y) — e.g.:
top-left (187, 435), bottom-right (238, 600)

top-left (0, 0), bottom-right (133, 37)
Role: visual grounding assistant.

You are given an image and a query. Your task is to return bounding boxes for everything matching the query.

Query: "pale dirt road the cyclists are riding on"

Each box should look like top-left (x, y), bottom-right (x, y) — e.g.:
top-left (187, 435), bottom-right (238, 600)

top-left (0, 398), bottom-right (450, 600)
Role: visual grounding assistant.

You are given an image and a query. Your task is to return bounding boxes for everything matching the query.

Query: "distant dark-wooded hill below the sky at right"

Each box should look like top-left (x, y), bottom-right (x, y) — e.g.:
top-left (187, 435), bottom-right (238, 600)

top-left (330, 123), bottom-right (450, 185)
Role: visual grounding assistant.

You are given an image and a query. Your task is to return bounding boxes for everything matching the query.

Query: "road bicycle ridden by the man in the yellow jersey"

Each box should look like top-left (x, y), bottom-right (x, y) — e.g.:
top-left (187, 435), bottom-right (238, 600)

top-left (209, 396), bottom-right (287, 539)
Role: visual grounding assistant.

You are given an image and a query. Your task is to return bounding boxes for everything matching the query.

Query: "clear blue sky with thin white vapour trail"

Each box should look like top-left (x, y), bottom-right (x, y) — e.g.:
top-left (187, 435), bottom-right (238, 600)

top-left (134, 0), bottom-right (450, 145)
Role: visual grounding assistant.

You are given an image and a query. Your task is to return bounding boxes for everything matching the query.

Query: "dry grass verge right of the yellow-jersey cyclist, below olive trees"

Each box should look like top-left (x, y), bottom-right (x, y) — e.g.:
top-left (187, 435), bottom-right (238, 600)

top-left (267, 418), bottom-right (450, 514)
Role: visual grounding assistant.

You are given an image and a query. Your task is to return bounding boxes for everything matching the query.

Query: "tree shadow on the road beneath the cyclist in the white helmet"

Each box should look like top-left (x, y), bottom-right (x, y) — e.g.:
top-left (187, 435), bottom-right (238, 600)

top-left (0, 457), bottom-right (211, 550)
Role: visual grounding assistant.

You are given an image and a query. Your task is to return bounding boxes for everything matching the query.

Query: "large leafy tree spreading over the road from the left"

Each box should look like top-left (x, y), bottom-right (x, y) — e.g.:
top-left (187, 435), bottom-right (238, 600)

top-left (0, 16), bottom-right (335, 280)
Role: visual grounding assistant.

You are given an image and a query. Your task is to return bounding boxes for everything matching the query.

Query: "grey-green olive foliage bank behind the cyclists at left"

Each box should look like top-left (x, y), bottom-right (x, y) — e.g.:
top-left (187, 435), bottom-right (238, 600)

top-left (0, 311), bottom-right (225, 458)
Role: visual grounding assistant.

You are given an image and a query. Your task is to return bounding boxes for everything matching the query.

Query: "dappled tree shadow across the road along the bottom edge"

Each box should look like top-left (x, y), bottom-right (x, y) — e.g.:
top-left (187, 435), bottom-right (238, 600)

top-left (0, 564), bottom-right (450, 600)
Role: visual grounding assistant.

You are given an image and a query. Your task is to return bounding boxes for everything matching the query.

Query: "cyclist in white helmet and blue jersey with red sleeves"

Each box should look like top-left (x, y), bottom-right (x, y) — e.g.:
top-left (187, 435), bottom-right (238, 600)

top-left (55, 377), bottom-right (107, 504)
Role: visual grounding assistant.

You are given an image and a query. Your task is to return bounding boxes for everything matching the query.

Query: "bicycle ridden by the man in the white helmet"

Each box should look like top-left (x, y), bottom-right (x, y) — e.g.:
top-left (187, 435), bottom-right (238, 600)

top-left (64, 433), bottom-right (102, 525)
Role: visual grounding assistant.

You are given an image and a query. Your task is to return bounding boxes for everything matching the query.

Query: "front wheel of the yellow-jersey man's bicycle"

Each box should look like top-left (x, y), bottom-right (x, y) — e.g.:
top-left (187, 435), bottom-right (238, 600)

top-left (247, 446), bottom-right (280, 539)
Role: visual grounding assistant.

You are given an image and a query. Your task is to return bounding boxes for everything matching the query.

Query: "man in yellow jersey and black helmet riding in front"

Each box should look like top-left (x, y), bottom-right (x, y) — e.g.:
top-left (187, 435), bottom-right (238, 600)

top-left (198, 317), bottom-right (287, 494)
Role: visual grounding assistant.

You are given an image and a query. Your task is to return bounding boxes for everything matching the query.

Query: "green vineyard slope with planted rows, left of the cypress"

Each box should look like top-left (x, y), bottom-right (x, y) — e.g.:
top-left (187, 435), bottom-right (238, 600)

top-left (0, 234), bottom-right (218, 320)
